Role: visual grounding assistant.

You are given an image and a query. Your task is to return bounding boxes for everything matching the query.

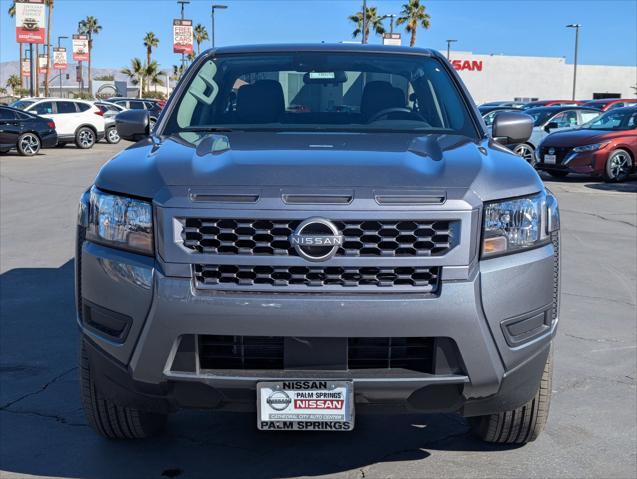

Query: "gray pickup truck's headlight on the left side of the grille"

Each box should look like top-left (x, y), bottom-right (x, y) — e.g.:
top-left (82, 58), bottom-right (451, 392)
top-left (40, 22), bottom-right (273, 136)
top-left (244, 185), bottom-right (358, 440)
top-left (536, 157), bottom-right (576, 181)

top-left (86, 187), bottom-right (153, 255)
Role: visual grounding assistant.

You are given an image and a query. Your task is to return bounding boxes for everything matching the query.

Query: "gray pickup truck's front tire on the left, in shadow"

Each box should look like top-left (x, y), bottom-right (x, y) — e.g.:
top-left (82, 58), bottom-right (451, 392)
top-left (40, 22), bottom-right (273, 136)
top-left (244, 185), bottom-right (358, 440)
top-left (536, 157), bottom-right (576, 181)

top-left (80, 340), bottom-right (166, 439)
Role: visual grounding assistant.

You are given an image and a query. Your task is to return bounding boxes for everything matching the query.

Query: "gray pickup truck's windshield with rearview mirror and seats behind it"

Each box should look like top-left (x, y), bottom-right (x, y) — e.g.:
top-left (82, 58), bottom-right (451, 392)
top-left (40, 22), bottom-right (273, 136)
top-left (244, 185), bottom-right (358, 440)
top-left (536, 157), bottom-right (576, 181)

top-left (163, 52), bottom-right (478, 138)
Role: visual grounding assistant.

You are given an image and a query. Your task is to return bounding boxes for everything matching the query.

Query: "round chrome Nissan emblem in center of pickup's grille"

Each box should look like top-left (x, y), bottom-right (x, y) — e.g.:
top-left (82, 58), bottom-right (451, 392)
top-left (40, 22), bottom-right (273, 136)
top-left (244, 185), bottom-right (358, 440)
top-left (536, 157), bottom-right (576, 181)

top-left (290, 218), bottom-right (343, 261)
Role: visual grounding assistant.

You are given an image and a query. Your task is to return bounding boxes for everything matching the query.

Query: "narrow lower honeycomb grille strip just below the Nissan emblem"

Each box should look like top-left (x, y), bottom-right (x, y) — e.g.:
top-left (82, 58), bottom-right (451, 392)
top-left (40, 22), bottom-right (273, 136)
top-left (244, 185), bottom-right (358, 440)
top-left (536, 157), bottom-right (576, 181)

top-left (194, 264), bottom-right (440, 293)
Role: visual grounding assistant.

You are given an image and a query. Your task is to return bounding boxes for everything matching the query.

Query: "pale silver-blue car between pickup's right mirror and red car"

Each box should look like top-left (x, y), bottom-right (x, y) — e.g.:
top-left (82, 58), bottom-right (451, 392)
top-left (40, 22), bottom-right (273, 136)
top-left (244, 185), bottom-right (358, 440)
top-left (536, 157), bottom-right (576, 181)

top-left (509, 106), bottom-right (600, 164)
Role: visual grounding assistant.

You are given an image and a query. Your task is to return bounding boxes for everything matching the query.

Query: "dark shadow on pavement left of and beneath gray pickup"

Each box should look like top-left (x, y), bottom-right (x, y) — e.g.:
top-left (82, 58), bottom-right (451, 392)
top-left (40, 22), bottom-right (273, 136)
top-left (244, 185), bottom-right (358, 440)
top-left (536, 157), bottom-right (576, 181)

top-left (0, 260), bottom-right (516, 478)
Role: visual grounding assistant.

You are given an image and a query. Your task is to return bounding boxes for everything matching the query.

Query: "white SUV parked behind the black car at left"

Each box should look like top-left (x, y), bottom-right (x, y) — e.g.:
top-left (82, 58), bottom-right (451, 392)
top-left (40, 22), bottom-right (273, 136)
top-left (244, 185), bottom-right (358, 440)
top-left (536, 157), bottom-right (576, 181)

top-left (14, 98), bottom-right (105, 149)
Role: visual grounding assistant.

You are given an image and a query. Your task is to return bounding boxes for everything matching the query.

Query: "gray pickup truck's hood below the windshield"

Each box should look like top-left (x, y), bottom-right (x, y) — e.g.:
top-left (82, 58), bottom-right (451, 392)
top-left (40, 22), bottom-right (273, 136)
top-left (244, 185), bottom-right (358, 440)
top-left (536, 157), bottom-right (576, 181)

top-left (95, 132), bottom-right (542, 201)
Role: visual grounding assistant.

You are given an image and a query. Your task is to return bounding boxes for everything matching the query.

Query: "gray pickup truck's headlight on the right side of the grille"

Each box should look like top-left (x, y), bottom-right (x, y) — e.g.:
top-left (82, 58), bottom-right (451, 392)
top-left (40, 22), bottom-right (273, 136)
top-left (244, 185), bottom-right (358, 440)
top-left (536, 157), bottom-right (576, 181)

top-left (482, 192), bottom-right (560, 258)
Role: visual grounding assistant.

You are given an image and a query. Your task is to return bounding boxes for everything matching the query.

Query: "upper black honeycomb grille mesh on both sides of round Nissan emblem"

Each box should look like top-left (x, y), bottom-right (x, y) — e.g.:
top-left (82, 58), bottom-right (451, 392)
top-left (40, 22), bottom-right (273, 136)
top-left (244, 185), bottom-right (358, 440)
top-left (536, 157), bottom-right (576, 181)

top-left (179, 218), bottom-right (459, 256)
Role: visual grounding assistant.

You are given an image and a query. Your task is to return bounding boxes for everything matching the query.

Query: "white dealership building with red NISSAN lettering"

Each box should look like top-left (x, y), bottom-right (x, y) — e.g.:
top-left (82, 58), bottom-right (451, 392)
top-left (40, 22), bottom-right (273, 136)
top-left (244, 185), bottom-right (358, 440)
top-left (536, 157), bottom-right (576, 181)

top-left (449, 51), bottom-right (637, 104)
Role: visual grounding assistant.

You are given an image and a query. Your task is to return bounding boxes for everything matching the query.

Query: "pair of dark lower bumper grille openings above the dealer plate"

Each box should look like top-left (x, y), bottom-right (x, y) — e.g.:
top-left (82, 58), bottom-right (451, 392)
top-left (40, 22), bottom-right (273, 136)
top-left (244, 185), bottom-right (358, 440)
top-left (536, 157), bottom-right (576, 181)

top-left (199, 335), bottom-right (435, 374)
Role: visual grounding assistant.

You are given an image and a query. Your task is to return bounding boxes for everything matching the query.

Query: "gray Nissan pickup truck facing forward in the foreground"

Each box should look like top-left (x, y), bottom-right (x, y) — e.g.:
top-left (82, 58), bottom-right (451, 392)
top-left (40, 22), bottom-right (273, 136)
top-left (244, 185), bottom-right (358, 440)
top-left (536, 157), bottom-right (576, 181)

top-left (76, 44), bottom-right (560, 443)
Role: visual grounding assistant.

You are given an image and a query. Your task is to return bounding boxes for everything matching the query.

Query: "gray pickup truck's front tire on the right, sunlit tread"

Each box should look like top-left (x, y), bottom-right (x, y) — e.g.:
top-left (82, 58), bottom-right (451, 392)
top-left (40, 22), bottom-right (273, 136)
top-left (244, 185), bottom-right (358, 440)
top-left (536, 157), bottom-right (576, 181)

top-left (471, 351), bottom-right (553, 444)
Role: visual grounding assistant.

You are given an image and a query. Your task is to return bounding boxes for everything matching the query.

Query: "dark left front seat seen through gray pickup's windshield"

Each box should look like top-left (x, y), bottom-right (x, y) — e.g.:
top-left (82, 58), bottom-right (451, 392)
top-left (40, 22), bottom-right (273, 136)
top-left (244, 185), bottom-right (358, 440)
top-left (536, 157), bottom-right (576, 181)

top-left (236, 80), bottom-right (285, 123)
